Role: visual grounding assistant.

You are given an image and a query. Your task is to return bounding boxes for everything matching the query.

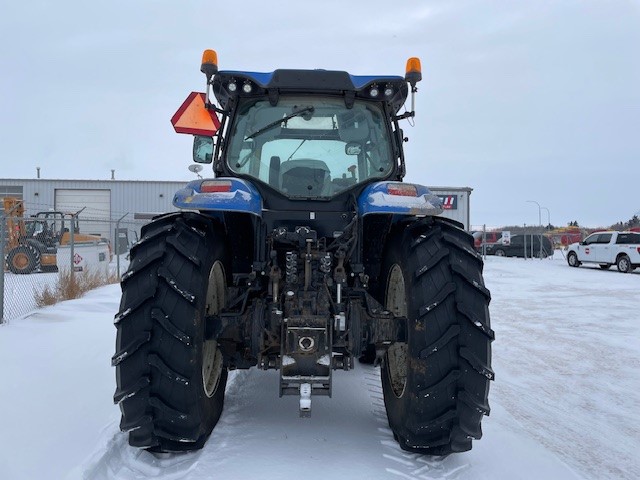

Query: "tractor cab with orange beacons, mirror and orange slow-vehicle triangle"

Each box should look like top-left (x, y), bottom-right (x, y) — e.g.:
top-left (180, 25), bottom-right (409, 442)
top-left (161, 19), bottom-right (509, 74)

top-left (172, 51), bottom-right (421, 210)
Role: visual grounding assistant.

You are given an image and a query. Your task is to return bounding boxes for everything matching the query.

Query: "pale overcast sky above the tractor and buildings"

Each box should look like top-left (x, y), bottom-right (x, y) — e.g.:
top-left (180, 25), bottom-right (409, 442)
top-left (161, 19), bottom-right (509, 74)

top-left (0, 0), bottom-right (640, 226)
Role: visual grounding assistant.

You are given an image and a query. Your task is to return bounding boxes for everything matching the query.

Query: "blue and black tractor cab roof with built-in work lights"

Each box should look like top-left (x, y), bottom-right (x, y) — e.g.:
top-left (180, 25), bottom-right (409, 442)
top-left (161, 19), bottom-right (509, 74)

top-left (213, 70), bottom-right (408, 114)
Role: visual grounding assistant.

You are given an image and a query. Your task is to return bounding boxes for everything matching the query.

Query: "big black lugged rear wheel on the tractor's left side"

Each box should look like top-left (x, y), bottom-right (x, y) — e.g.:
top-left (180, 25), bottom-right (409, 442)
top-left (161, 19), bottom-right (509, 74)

top-left (112, 213), bottom-right (227, 452)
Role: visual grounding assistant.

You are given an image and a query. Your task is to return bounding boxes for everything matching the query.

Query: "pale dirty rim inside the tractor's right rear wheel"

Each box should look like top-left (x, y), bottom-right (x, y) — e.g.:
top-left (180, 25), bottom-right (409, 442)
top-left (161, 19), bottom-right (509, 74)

top-left (386, 264), bottom-right (409, 398)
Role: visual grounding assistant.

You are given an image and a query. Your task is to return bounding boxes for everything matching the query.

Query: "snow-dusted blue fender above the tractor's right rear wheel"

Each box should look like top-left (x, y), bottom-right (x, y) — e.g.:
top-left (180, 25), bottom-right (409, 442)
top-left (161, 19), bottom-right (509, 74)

top-left (358, 181), bottom-right (443, 216)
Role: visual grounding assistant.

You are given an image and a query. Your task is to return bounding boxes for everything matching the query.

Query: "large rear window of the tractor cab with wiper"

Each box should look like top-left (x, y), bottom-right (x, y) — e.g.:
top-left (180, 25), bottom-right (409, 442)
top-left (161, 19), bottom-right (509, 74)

top-left (222, 95), bottom-right (394, 199)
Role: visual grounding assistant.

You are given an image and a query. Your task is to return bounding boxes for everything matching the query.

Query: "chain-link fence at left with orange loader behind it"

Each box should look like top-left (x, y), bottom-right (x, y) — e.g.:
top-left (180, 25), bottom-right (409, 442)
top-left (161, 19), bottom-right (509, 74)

top-left (0, 212), bottom-right (148, 323)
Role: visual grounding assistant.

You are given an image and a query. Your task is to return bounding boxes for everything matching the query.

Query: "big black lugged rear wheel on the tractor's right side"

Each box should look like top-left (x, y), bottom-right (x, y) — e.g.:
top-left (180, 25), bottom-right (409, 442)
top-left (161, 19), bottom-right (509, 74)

top-left (381, 218), bottom-right (494, 455)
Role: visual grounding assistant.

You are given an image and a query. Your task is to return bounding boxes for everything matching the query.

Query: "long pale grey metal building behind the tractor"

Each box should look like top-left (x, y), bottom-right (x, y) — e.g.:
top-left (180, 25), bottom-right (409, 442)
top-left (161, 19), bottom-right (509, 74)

top-left (0, 178), bottom-right (472, 248)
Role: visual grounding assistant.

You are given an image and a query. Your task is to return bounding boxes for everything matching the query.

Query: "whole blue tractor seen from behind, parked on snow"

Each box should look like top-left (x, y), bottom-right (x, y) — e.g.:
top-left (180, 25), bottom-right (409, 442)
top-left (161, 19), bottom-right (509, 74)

top-left (112, 50), bottom-right (494, 455)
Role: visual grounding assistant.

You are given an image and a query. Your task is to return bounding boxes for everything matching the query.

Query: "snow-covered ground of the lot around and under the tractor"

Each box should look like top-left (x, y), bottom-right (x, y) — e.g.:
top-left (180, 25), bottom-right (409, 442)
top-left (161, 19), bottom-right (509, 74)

top-left (0, 252), bottom-right (640, 480)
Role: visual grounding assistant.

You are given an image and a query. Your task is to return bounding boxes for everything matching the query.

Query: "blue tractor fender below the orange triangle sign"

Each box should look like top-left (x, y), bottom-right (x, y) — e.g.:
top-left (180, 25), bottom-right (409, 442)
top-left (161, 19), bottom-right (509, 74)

top-left (173, 177), bottom-right (262, 217)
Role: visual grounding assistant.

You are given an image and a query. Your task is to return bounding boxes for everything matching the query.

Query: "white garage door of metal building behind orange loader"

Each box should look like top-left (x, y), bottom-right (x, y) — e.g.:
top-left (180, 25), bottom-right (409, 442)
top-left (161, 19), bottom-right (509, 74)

top-left (55, 189), bottom-right (112, 240)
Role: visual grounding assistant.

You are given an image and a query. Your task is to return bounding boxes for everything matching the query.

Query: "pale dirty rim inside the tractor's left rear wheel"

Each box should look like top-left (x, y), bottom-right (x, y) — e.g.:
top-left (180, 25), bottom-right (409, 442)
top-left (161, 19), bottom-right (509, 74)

top-left (202, 261), bottom-right (225, 397)
